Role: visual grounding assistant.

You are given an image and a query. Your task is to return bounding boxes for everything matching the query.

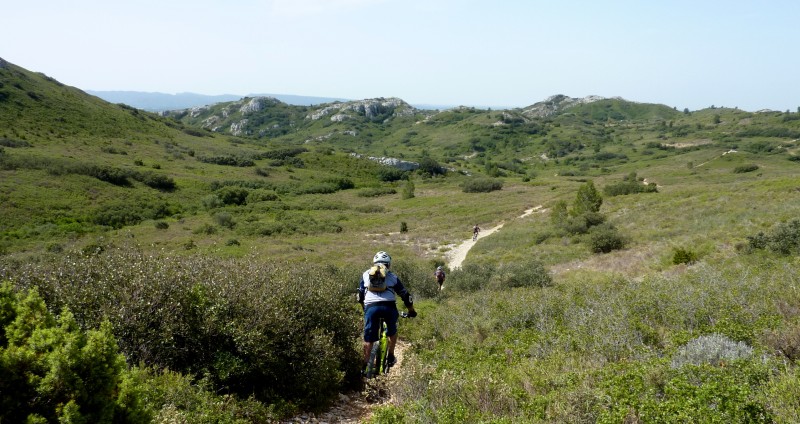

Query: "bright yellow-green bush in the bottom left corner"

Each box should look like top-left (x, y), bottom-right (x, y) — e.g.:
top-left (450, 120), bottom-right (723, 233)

top-left (0, 283), bottom-right (133, 422)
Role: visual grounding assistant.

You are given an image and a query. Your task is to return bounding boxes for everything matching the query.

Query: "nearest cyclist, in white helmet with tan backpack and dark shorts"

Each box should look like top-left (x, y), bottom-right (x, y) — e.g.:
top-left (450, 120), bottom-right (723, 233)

top-left (358, 251), bottom-right (417, 372)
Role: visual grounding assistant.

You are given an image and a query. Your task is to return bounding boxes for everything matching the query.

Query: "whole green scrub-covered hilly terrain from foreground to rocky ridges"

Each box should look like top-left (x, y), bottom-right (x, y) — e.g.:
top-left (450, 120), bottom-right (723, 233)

top-left (0, 60), bottom-right (800, 423)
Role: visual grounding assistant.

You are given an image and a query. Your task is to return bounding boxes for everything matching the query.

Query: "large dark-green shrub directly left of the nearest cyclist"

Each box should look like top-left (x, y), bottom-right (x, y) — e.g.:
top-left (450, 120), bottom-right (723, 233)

top-left (0, 248), bottom-right (360, 408)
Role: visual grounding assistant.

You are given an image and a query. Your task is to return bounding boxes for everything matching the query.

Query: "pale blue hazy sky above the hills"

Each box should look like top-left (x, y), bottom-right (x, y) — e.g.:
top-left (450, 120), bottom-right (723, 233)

top-left (0, 0), bottom-right (800, 112)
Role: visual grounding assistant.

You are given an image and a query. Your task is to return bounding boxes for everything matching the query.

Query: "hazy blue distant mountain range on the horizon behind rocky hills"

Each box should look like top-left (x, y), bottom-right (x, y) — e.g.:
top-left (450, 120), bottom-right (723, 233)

top-left (86, 90), bottom-right (348, 112)
